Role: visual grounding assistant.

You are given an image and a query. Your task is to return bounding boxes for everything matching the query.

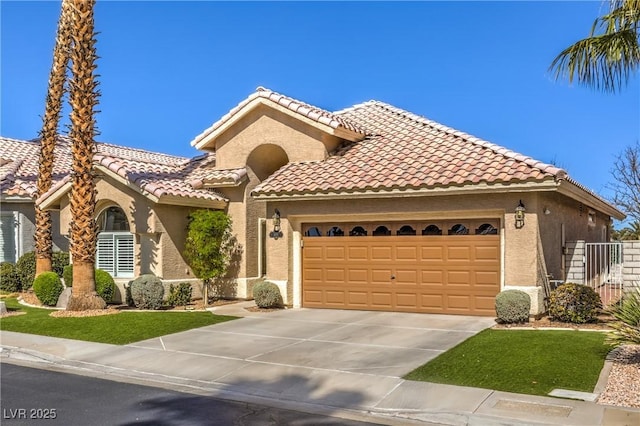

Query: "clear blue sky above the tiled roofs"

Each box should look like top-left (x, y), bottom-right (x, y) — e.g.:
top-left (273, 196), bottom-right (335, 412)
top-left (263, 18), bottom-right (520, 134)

top-left (0, 0), bottom-right (640, 201)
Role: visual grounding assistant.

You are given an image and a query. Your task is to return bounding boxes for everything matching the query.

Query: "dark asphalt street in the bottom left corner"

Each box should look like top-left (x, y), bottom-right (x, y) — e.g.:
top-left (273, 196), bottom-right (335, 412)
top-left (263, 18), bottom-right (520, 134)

top-left (0, 363), bottom-right (382, 426)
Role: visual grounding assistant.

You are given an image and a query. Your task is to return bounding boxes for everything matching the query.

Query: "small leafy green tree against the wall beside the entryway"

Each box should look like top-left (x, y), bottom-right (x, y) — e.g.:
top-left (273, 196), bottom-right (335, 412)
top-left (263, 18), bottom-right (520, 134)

top-left (183, 210), bottom-right (236, 306)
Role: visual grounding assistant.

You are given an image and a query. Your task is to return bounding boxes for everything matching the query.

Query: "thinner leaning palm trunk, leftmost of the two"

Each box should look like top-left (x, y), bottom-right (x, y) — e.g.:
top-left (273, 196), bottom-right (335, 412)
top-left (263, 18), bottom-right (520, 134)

top-left (35, 2), bottom-right (71, 275)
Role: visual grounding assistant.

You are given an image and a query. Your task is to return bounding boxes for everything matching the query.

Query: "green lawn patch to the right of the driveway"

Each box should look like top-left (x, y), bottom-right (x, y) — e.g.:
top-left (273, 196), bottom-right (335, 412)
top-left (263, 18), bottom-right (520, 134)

top-left (405, 330), bottom-right (611, 395)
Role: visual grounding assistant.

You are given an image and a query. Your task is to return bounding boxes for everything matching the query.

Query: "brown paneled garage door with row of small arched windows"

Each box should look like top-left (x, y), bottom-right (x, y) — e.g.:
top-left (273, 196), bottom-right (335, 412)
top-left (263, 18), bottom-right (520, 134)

top-left (302, 221), bottom-right (500, 315)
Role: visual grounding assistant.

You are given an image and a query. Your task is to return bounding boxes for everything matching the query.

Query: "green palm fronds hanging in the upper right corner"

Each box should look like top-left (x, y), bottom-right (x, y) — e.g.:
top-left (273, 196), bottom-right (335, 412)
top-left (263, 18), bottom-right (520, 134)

top-left (549, 0), bottom-right (640, 92)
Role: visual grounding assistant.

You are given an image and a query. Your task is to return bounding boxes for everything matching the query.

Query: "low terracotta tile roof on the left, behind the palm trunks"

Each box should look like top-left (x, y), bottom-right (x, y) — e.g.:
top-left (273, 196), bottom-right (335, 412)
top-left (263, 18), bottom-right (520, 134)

top-left (0, 136), bottom-right (226, 202)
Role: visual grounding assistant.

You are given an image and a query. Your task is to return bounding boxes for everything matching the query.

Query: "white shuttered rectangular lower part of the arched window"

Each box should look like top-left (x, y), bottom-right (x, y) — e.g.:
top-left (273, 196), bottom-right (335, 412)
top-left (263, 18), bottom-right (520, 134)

top-left (96, 232), bottom-right (134, 278)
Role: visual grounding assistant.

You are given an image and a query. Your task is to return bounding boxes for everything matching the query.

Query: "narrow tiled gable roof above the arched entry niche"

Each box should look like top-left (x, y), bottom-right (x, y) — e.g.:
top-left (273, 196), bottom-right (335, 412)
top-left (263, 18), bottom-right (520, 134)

top-left (191, 87), bottom-right (367, 146)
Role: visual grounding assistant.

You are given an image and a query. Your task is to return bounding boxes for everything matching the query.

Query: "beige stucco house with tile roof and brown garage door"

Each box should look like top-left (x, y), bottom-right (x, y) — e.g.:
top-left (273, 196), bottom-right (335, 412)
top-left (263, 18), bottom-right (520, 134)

top-left (3, 88), bottom-right (624, 315)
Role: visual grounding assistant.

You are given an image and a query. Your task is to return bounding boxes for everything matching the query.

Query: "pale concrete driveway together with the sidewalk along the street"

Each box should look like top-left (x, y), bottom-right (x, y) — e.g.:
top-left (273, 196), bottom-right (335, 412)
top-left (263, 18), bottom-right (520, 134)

top-left (0, 303), bottom-right (640, 425)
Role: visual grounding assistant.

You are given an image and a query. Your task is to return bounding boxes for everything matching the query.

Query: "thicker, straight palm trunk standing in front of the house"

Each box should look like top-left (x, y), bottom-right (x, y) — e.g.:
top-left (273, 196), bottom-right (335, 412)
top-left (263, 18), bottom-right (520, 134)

top-left (65, 0), bottom-right (106, 311)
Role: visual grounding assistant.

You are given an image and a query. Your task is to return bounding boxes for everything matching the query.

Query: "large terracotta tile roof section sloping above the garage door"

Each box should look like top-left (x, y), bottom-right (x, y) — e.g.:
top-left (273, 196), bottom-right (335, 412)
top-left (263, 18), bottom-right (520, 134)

top-left (253, 101), bottom-right (567, 196)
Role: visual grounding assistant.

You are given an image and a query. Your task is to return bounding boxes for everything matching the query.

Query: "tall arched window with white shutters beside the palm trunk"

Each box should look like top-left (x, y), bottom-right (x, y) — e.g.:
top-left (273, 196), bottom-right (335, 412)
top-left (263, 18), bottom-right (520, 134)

top-left (96, 206), bottom-right (133, 278)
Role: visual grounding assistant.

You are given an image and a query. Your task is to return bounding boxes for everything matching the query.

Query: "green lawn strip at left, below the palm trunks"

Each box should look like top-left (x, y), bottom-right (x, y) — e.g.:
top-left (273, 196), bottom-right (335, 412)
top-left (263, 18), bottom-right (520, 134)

top-left (0, 298), bottom-right (236, 345)
